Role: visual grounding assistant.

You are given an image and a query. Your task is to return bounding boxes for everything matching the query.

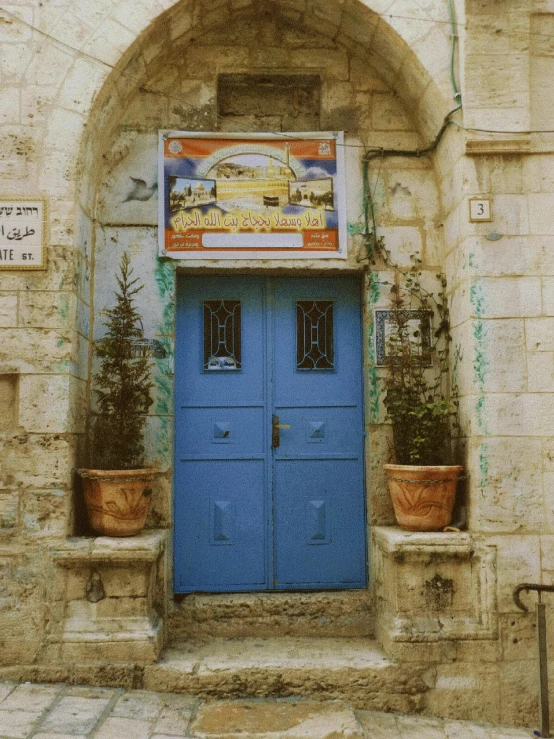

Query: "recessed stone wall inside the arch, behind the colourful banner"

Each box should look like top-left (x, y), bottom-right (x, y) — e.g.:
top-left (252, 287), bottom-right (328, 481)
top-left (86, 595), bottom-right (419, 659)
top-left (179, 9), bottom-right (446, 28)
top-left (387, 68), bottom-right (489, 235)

top-left (90, 8), bottom-right (443, 536)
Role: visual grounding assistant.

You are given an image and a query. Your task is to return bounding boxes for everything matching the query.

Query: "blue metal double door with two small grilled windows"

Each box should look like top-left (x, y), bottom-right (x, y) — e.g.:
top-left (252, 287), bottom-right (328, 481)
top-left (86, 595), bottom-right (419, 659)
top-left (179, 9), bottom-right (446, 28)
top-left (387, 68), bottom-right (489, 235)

top-left (174, 276), bottom-right (366, 593)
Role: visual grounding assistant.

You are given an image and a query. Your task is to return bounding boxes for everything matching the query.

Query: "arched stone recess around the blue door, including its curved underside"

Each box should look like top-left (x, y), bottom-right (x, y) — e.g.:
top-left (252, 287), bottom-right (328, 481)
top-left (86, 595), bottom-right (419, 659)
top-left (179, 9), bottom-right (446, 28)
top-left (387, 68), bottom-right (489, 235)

top-left (70, 2), bottom-right (447, 633)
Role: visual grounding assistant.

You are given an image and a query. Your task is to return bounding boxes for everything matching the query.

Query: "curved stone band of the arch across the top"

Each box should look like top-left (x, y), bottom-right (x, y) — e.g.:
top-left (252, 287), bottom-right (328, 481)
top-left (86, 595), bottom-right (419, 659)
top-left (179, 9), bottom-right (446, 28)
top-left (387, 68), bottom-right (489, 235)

top-left (80, 0), bottom-right (451, 215)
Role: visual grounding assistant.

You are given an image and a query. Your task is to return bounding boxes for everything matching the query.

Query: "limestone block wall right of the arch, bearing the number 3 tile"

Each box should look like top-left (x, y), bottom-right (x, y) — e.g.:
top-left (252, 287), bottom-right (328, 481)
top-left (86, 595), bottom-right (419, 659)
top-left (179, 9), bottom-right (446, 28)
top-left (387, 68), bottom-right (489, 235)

top-left (435, 137), bottom-right (553, 723)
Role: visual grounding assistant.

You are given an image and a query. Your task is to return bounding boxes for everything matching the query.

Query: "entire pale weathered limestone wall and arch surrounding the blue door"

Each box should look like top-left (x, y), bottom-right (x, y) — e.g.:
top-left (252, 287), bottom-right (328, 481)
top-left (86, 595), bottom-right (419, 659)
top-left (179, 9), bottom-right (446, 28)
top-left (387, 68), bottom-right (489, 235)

top-left (0, 0), bottom-right (554, 722)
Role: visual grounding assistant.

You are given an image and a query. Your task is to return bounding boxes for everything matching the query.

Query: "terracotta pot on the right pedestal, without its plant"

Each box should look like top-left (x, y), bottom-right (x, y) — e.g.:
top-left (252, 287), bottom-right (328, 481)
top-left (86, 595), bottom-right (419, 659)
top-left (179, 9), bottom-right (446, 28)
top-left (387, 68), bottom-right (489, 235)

top-left (385, 464), bottom-right (463, 531)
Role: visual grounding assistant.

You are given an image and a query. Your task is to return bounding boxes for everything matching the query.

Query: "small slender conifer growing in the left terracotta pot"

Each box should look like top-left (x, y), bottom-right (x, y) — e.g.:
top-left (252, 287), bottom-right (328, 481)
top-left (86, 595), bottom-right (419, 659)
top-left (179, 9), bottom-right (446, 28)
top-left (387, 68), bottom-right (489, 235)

top-left (93, 252), bottom-right (154, 469)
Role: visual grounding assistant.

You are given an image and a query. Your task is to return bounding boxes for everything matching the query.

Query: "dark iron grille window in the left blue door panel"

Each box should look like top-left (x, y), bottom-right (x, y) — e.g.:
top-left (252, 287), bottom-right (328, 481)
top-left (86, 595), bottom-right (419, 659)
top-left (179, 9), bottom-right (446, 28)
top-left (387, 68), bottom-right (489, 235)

top-left (204, 300), bottom-right (241, 371)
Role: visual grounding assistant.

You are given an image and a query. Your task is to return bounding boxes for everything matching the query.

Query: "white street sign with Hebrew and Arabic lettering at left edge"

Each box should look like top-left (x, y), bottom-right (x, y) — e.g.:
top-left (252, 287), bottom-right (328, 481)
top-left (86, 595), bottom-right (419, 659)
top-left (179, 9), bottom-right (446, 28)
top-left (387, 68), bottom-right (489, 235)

top-left (0, 199), bottom-right (46, 270)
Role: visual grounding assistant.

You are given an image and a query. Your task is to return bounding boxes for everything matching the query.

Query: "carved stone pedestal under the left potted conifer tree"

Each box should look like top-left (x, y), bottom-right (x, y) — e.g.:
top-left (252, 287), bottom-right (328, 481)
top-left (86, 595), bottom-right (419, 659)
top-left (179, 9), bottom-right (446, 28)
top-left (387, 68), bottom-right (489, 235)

top-left (54, 530), bottom-right (167, 665)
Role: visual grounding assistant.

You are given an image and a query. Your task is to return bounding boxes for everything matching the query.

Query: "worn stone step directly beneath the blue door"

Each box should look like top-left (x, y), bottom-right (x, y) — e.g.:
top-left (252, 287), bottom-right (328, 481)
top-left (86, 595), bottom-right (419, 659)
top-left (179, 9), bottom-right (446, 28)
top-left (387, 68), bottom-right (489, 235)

top-left (169, 590), bottom-right (374, 640)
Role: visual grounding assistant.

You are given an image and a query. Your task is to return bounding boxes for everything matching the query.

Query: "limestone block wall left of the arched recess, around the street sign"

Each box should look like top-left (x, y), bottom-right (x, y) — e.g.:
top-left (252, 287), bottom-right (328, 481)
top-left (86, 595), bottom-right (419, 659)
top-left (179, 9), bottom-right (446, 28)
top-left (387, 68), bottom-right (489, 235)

top-left (0, 3), bottom-right (88, 664)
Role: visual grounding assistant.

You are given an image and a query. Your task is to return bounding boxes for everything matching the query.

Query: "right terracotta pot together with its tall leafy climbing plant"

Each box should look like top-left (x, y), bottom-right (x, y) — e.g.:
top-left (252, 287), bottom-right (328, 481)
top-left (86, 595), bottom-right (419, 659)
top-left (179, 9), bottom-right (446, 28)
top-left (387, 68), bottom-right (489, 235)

top-left (383, 255), bottom-right (462, 531)
